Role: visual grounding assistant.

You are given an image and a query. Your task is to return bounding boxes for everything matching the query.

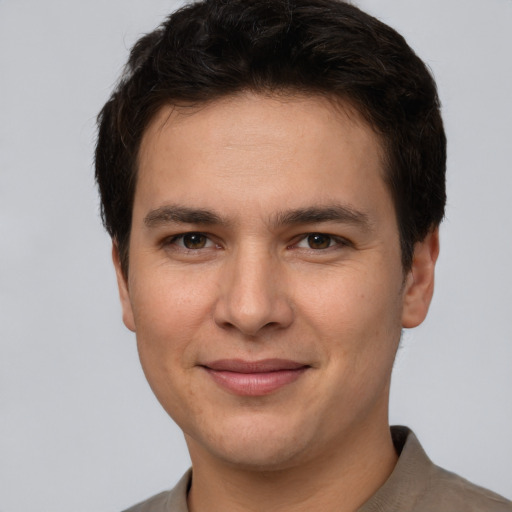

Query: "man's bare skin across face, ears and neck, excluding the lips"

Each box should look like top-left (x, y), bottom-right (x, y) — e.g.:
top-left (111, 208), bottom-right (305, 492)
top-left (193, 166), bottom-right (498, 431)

top-left (113, 93), bottom-right (438, 511)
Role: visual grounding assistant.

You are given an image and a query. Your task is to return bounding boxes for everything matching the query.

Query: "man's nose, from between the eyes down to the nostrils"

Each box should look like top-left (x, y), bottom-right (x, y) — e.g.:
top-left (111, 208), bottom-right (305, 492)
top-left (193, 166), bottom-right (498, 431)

top-left (214, 249), bottom-right (294, 337)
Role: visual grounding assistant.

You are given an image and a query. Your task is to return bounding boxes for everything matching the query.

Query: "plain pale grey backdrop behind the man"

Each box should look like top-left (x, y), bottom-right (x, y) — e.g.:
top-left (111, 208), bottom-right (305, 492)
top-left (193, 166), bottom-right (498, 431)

top-left (0, 0), bottom-right (512, 512)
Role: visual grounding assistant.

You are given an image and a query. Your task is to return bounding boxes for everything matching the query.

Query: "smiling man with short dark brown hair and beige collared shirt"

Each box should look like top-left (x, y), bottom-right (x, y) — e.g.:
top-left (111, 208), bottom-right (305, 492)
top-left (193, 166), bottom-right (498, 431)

top-left (96, 0), bottom-right (512, 512)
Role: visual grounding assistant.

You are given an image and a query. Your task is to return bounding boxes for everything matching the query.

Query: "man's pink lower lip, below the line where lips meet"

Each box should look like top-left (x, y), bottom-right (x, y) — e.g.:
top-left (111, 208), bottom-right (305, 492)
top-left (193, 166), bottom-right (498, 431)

top-left (206, 367), bottom-right (307, 396)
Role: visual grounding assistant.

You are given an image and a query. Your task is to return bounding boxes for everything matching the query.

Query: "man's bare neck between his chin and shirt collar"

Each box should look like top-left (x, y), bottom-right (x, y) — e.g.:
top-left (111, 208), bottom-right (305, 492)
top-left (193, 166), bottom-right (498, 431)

top-left (187, 422), bottom-right (397, 512)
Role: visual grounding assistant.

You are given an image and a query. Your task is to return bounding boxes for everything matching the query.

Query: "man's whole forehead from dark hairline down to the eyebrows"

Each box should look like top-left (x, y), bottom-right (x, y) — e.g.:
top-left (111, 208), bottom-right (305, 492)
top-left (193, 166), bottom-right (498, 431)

top-left (134, 93), bottom-right (387, 222)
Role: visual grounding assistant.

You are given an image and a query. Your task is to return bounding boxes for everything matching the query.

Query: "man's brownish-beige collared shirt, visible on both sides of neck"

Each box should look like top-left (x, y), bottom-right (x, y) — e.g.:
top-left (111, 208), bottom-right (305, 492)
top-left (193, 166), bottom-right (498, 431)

top-left (125, 427), bottom-right (512, 512)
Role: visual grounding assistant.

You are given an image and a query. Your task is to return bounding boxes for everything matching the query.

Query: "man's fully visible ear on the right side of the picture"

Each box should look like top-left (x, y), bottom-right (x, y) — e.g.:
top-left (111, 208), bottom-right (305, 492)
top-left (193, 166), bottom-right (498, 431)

top-left (402, 228), bottom-right (439, 327)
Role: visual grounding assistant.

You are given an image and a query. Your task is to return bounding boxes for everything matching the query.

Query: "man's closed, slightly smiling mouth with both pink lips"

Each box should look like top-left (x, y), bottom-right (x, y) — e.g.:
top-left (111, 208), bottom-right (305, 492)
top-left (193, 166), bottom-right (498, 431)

top-left (201, 359), bottom-right (311, 396)
